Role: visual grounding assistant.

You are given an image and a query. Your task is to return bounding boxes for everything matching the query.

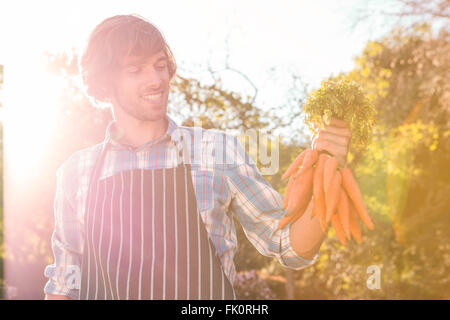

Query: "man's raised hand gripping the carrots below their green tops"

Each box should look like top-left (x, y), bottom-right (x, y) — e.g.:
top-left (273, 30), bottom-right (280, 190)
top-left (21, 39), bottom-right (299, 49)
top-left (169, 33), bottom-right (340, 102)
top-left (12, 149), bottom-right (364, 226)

top-left (312, 117), bottom-right (351, 167)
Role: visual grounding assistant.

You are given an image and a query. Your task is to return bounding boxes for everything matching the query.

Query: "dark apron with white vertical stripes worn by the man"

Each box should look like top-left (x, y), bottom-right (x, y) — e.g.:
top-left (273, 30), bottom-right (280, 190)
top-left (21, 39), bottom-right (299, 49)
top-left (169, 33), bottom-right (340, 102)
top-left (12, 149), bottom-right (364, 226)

top-left (79, 143), bottom-right (236, 300)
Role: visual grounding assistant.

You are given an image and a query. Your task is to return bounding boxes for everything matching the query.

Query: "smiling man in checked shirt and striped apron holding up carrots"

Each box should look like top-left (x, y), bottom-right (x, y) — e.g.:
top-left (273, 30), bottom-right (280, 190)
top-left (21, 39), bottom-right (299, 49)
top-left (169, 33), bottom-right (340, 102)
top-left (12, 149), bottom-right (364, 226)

top-left (44, 15), bottom-right (350, 299)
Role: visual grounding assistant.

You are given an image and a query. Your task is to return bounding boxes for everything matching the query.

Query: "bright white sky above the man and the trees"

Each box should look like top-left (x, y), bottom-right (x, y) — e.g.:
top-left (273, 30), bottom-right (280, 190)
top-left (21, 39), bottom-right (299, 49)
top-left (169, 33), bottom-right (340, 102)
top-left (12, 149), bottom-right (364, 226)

top-left (0, 0), bottom-right (400, 108)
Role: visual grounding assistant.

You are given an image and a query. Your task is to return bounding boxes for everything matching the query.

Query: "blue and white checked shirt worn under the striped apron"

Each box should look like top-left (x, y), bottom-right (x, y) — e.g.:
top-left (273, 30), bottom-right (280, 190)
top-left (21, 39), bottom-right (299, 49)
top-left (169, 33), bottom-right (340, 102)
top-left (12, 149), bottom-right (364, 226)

top-left (44, 116), bottom-right (318, 299)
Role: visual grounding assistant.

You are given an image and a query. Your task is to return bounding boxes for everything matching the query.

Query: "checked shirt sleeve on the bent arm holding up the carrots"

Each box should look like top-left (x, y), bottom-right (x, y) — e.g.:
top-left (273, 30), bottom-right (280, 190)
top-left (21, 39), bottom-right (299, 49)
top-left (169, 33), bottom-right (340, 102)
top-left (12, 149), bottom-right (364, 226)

top-left (227, 138), bottom-right (319, 270)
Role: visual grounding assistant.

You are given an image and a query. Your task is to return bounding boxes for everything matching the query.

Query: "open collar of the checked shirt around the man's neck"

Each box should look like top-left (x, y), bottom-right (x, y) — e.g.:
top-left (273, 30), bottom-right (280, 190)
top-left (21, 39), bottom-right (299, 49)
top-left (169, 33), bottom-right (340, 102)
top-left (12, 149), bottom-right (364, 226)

top-left (105, 114), bottom-right (180, 149)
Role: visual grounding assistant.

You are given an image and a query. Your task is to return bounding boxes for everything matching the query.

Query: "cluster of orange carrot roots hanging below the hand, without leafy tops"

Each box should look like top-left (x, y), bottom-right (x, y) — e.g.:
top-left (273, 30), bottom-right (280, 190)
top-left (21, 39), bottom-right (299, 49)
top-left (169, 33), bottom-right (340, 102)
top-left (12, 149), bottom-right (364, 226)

top-left (278, 149), bottom-right (374, 246)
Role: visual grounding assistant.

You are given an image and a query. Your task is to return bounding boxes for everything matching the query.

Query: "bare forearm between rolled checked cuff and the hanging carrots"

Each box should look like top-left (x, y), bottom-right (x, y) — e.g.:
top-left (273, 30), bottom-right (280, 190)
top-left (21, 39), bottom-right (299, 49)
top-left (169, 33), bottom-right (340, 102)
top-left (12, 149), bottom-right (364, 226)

top-left (289, 199), bottom-right (326, 260)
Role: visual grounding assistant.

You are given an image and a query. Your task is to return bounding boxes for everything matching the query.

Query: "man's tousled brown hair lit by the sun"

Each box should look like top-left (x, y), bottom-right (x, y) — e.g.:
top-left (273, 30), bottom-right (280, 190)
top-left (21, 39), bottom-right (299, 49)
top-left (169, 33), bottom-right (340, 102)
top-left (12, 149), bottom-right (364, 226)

top-left (80, 14), bottom-right (177, 102)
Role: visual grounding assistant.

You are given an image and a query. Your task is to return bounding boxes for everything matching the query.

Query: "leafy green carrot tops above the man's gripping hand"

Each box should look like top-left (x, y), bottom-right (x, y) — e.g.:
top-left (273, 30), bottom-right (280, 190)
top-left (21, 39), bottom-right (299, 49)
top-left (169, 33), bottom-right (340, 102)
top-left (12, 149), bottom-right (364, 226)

top-left (303, 79), bottom-right (375, 150)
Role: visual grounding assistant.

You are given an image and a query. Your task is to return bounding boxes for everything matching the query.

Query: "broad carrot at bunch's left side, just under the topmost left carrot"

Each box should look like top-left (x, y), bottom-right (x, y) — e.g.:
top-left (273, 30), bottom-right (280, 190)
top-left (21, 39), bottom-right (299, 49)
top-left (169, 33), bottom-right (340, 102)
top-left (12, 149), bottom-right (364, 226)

top-left (286, 168), bottom-right (314, 216)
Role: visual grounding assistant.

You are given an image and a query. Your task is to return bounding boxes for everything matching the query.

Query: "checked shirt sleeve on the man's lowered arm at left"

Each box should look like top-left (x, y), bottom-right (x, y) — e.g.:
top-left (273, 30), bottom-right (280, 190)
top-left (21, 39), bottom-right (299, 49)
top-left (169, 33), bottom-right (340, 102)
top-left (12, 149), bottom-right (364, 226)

top-left (44, 164), bottom-right (82, 299)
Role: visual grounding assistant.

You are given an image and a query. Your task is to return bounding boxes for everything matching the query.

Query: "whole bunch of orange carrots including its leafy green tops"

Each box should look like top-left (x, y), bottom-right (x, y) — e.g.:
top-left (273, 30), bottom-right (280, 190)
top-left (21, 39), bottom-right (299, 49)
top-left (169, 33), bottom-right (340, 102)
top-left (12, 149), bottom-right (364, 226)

top-left (278, 79), bottom-right (376, 246)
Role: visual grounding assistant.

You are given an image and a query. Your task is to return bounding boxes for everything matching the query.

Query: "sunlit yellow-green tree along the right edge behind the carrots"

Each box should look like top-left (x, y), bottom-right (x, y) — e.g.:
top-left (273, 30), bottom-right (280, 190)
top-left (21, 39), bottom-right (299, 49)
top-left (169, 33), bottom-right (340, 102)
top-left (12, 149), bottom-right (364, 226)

top-left (310, 25), bottom-right (450, 299)
